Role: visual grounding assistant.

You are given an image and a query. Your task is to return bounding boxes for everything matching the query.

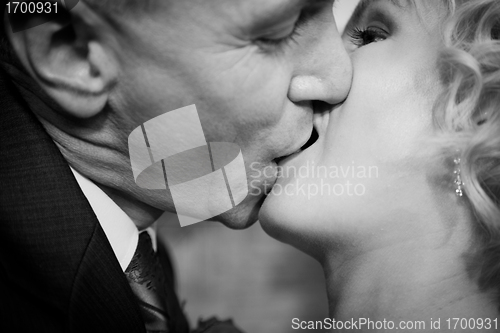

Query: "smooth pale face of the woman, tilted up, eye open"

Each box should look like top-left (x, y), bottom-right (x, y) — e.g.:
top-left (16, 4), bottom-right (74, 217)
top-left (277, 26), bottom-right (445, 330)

top-left (261, 0), bottom-right (453, 255)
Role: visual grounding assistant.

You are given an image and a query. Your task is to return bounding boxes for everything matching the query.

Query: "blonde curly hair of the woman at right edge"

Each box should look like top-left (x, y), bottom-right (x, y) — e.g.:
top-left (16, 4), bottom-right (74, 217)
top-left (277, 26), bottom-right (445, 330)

top-left (434, 0), bottom-right (500, 302)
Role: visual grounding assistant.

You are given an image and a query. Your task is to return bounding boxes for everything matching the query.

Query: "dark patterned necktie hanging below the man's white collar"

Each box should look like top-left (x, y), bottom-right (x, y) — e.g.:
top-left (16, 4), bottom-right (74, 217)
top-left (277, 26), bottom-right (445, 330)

top-left (125, 232), bottom-right (172, 333)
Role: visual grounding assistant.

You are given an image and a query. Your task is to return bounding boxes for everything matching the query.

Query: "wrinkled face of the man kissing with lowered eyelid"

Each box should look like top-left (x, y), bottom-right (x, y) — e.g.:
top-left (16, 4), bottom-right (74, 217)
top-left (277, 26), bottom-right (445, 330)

top-left (110, 0), bottom-right (351, 228)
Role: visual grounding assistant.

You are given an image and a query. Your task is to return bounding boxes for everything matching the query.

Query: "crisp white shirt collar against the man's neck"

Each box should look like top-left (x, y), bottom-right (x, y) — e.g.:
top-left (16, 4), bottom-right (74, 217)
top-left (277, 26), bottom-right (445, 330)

top-left (70, 167), bottom-right (139, 272)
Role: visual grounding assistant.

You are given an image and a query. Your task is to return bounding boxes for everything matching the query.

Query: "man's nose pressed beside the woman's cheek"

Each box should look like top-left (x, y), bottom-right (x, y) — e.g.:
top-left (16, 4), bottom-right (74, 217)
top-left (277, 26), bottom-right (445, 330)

top-left (288, 16), bottom-right (352, 105)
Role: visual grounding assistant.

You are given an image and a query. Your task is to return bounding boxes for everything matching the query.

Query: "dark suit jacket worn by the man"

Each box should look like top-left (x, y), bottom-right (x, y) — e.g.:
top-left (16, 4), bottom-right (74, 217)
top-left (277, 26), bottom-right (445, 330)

top-left (0, 63), bottom-right (188, 333)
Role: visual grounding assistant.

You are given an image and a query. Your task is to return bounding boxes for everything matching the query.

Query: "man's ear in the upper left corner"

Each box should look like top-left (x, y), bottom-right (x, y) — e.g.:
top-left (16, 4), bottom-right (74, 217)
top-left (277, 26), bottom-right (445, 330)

top-left (7, 1), bottom-right (118, 118)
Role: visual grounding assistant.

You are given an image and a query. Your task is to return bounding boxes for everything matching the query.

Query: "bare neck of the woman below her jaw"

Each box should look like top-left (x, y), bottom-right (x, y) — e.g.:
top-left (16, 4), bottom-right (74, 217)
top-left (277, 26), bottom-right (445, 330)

top-left (324, 205), bottom-right (498, 332)
